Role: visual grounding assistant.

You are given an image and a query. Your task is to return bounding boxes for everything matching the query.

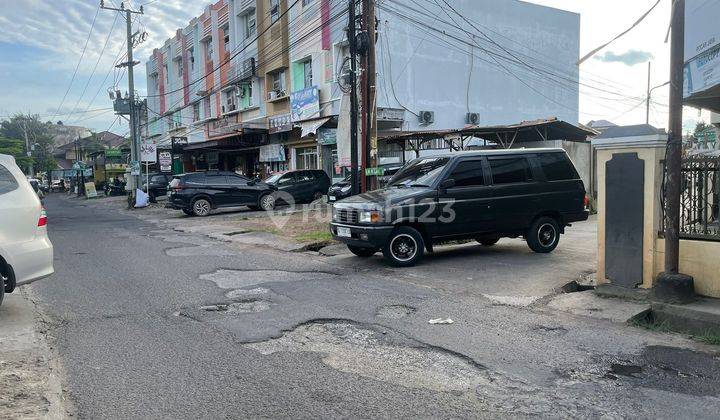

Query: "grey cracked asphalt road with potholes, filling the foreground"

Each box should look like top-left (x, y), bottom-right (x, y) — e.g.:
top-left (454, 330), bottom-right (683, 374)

top-left (19, 195), bottom-right (720, 418)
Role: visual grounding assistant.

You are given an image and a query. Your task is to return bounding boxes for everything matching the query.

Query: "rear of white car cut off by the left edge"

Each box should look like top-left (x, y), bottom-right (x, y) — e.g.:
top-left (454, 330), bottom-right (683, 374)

top-left (0, 154), bottom-right (54, 304)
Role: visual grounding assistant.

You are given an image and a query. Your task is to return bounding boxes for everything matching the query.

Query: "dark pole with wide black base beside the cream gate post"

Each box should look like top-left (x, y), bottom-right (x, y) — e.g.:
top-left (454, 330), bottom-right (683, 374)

top-left (653, 0), bottom-right (695, 303)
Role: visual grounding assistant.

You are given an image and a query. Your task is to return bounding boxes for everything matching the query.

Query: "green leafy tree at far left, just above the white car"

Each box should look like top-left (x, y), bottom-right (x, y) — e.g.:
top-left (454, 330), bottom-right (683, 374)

top-left (0, 114), bottom-right (57, 172)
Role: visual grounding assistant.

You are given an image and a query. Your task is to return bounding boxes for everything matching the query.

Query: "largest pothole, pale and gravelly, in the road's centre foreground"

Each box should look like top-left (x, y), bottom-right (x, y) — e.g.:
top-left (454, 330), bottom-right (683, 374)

top-left (245, 321), bottom-right (493, 393)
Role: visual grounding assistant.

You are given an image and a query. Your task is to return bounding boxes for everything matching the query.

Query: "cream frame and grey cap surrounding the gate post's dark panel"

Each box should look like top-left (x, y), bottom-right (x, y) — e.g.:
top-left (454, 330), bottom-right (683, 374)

top-left (592, 134), bottom-right (667, 288)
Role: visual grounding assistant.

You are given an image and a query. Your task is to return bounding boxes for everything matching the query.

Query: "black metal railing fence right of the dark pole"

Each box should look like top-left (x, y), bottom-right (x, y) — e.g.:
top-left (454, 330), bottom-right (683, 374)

top-left (680, 156), bottom-right (720, 241)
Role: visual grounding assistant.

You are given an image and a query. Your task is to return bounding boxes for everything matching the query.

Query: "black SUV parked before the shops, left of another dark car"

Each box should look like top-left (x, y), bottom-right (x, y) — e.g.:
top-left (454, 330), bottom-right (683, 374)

top-left (165, 171), bottom-right (277, 216)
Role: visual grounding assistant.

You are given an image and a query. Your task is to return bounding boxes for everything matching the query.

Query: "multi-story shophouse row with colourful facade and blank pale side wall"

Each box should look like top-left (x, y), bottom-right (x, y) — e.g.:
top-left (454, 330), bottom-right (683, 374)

top-left (146, 0), bottom-right (580, 181)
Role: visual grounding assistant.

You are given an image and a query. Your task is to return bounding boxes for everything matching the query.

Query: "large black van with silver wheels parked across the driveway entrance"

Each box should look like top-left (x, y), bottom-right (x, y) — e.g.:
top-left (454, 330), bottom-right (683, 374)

top-left (330, 149), bottom-right (588, 266)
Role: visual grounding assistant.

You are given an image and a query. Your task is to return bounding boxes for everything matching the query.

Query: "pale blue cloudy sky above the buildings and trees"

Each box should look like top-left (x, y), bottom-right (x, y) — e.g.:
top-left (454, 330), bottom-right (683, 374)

top-left (0, 0), bottom-right (708, 135)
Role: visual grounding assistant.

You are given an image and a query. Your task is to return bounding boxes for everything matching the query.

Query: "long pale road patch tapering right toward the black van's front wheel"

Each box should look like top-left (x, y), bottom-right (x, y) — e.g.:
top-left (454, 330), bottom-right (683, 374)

top-left (200, 269), bottom-right (336, 289)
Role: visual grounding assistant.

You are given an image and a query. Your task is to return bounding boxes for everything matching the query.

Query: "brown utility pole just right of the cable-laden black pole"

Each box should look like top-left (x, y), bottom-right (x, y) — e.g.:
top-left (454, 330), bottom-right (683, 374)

top-left (362, 0), bottom-right (377, 192)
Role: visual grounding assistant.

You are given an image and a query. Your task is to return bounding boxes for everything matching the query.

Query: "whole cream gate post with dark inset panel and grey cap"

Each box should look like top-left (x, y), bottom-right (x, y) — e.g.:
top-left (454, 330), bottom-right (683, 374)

top-left (592, 130), bottom-right (667, 288)
